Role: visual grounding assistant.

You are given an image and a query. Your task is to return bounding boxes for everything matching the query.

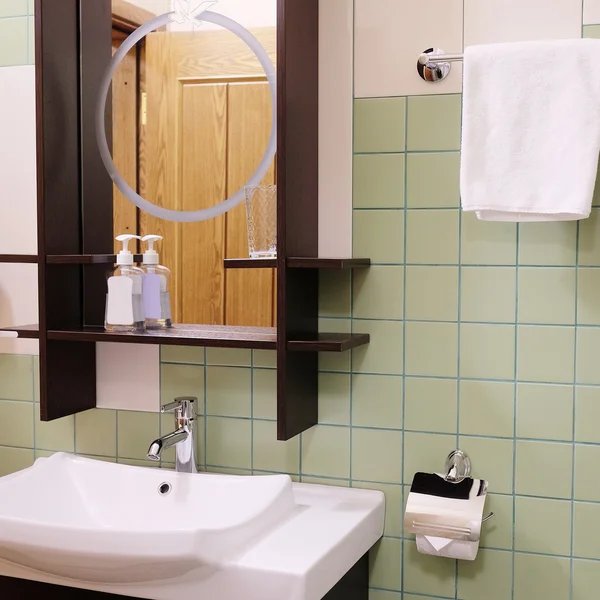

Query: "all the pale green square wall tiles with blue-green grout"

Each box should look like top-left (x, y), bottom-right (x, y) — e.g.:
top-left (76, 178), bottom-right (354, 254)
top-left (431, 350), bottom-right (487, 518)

top-left (0, 7), bottom-right (600, 600)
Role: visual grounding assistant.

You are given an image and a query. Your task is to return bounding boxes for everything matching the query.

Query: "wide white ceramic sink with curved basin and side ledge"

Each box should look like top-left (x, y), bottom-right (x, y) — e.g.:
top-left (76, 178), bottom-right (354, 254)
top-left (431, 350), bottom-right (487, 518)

top-left (0, 453), bottom-right (385, 600)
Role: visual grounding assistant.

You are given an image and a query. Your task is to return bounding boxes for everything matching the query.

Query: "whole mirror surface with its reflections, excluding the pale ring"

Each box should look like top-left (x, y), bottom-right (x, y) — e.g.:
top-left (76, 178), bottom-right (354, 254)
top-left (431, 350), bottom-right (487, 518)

top-left (112, 0), bottom-right (277, 327)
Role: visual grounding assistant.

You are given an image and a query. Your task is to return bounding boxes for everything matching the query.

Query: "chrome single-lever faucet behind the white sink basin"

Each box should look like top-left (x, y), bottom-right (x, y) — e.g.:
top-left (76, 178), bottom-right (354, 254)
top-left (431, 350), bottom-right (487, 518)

top-left (148, 396), bottom-right (198, 473)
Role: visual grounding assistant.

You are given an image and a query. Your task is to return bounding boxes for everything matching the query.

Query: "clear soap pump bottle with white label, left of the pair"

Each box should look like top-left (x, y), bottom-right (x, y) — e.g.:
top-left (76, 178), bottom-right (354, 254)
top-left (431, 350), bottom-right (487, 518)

top-left (104, 235), bottom-right (146, 332)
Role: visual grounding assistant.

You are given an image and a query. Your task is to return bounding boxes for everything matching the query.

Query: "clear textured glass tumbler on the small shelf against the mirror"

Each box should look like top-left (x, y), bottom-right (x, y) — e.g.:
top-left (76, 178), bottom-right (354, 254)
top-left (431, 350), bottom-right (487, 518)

top-left (245, 185), bottom-right (277, 258)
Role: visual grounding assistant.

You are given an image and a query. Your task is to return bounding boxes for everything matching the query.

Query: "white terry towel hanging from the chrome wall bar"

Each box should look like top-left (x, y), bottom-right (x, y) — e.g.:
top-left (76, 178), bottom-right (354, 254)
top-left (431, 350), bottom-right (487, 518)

top-left (460, 40), bottom-right (600, 221)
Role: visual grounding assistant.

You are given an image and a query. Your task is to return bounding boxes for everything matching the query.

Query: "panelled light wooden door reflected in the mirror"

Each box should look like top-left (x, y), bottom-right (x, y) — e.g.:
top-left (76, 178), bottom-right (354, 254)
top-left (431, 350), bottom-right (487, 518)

top-left (140, 28), bottom-right (276, 326)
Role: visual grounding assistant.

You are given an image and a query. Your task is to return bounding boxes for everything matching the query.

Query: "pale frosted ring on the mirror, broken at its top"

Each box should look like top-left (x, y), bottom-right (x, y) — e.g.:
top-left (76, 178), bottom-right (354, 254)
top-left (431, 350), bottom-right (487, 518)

top-left (96, 11), bottom-right (277, 223)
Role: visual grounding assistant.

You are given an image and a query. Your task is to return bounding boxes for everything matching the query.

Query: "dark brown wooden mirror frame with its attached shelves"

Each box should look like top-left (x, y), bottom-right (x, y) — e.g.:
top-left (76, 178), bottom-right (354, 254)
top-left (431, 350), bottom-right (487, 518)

top-left (0, 0), bottom-right (370, 440)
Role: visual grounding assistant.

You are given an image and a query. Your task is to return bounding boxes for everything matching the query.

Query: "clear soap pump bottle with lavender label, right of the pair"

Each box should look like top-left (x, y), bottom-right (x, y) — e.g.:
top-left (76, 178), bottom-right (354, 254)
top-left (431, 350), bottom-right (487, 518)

top-left (141, 235), bottom-right (172, 329)
